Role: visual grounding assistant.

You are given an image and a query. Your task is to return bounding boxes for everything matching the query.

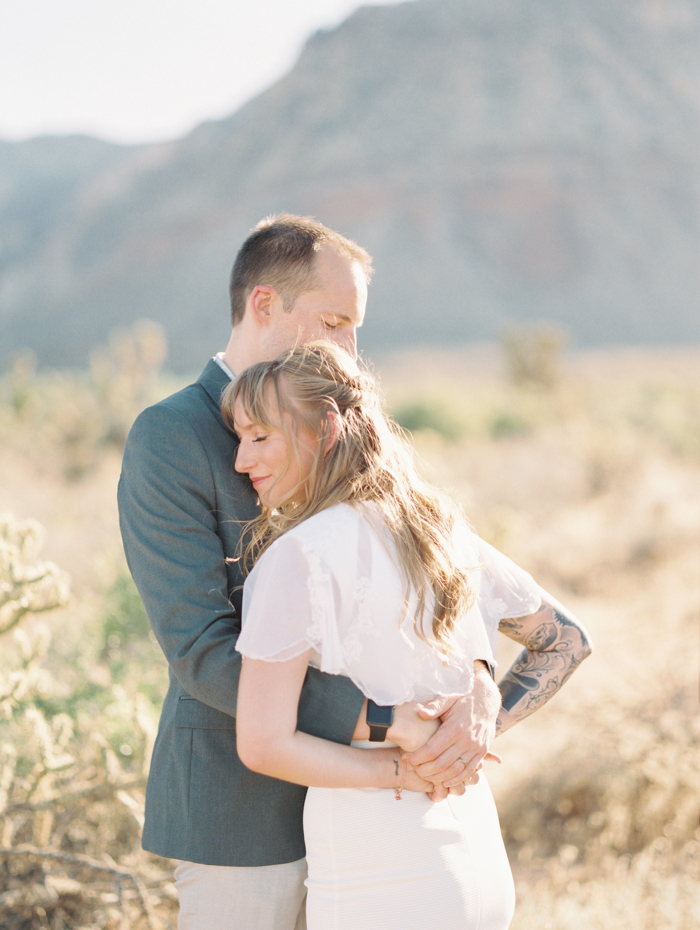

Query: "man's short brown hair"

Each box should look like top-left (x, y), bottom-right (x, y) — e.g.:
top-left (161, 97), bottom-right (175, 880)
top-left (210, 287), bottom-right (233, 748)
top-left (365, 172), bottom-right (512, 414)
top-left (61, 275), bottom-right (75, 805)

top-left (229, 213), bottom-right (372, 326)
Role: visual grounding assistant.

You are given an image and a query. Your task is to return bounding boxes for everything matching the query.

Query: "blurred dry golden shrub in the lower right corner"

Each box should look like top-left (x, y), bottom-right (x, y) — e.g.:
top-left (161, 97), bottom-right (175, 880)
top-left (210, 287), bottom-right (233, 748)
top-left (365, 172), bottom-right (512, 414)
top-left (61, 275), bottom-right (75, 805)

top-left (500, 687), bottom-right (700, 930)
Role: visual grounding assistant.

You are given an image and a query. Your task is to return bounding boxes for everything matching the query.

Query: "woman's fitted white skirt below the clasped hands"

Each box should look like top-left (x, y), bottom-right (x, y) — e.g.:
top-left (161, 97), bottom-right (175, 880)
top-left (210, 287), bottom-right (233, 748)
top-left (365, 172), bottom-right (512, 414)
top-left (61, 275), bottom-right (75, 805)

top-left (304, 773), bottom-right (515, 930)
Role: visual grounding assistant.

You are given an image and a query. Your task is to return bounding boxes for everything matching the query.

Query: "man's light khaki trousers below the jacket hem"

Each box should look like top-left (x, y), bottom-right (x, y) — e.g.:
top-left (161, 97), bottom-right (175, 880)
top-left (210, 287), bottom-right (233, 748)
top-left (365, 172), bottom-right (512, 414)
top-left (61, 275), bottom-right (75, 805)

top-left (175, 859), bottom-right (306, 930)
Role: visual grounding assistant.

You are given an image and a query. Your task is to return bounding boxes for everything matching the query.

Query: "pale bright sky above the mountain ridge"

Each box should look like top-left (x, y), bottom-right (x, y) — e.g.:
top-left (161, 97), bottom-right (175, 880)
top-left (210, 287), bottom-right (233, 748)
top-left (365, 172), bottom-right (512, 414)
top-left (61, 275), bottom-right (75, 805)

top-left (0, 0), bottom-right (408, 143)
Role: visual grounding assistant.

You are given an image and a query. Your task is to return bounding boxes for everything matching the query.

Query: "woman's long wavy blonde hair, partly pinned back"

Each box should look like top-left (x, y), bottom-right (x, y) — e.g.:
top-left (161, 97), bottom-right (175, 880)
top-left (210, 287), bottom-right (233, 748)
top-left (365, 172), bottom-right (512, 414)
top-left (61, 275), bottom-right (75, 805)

top-left (221, 342), bottom-right (474, 652)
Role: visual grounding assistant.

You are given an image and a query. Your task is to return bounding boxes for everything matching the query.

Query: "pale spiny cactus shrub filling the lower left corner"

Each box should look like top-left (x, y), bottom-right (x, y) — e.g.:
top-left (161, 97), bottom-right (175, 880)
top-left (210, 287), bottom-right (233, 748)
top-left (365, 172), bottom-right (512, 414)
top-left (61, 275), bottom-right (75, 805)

top-left (0, 518), bottom-right (171, 930)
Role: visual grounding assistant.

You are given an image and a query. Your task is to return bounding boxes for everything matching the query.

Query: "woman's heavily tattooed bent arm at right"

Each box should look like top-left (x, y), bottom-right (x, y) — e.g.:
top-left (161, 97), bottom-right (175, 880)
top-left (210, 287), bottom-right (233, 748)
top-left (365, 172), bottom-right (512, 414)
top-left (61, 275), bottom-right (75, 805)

top-left (496, 602), bottom-right (592, 734)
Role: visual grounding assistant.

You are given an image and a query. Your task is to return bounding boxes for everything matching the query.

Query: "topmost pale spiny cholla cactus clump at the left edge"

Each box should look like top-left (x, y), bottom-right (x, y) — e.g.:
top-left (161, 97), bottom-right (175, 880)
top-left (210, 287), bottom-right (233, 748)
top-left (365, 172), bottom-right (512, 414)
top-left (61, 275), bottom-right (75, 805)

top-left (0, 514), bottom-right (70, 634)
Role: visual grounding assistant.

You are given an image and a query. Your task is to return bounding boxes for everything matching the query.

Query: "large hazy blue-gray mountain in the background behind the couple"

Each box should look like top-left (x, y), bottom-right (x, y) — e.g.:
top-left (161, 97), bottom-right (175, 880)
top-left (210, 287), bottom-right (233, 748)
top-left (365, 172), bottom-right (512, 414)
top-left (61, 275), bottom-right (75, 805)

top-left (0, 0), bottom-right (700, 370)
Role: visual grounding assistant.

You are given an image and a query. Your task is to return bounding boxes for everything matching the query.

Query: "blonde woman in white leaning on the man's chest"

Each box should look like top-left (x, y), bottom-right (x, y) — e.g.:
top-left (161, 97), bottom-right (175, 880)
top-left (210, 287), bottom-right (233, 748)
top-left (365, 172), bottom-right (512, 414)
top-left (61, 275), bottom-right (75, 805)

top-left (222, 344), bottom-right (587, 930)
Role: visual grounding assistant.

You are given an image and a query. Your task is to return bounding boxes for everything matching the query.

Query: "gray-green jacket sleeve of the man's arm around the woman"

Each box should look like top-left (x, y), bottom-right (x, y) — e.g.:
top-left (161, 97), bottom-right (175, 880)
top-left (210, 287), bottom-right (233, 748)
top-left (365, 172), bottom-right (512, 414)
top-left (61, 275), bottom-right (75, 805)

top-left (118, 405), bottom-right (363, 743)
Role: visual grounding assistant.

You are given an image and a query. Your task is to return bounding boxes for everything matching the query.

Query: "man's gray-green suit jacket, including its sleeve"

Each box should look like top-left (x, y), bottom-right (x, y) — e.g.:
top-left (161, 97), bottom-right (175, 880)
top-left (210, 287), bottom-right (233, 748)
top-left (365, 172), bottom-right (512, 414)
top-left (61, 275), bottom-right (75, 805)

top-left (119, 361), bottom-right (363, 866)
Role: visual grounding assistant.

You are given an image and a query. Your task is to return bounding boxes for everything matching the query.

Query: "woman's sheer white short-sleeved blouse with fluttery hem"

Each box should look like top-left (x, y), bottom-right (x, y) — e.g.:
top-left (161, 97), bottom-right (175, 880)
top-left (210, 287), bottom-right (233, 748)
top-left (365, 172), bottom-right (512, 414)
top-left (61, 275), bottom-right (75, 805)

top-left (236, 504), bottom-right (542, 705)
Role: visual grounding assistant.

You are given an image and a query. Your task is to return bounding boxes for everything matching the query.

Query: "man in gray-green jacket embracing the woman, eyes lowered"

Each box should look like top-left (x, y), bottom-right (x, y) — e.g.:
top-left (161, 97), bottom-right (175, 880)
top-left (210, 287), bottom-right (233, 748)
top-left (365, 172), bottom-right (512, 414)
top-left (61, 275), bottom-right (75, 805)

top-left (119, 215), bottom-right (499, 930)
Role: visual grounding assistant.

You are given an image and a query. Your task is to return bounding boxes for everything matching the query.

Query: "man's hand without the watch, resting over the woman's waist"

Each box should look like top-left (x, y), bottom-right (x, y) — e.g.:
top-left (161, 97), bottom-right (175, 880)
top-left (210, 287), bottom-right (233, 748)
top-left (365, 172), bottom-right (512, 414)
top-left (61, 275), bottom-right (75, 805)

top-left (406, 661), bottom-right (501, 788)
